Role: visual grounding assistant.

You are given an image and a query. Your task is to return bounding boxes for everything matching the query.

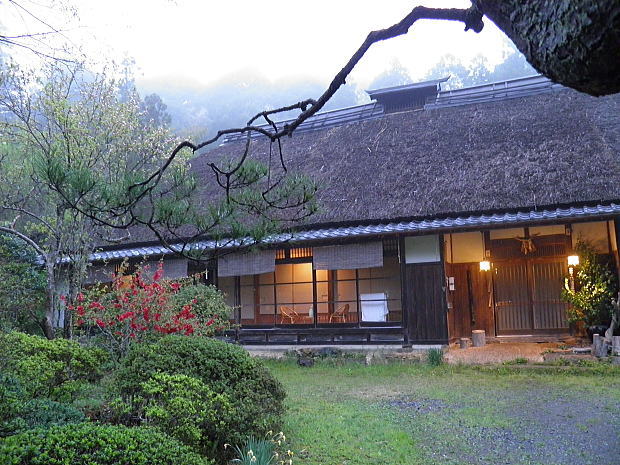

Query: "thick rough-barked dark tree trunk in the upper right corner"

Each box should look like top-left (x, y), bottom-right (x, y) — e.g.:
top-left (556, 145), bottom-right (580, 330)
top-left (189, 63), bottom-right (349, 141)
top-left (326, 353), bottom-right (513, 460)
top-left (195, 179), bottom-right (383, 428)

top-left (474, 0), bottom-right (620, 96)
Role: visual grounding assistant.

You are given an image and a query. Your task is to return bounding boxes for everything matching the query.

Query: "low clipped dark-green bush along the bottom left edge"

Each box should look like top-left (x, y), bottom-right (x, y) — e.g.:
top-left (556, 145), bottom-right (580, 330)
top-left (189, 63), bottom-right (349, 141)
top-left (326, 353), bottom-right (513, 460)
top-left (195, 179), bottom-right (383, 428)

top-left (0, 423), bottom-right (213, 465)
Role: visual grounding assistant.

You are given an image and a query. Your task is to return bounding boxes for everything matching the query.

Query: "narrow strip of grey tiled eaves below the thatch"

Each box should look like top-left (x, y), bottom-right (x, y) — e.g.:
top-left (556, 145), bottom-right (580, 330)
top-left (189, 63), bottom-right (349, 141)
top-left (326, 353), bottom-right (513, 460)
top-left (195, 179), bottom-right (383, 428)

top-left (90, 203), bottom-right (620, 261)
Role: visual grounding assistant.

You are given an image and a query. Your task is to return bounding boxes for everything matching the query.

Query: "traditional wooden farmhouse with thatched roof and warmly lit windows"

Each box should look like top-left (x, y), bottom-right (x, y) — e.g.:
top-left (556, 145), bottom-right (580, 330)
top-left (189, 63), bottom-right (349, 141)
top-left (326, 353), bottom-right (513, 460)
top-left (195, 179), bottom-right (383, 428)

top-left (87, 76), bottom-right (620, 346)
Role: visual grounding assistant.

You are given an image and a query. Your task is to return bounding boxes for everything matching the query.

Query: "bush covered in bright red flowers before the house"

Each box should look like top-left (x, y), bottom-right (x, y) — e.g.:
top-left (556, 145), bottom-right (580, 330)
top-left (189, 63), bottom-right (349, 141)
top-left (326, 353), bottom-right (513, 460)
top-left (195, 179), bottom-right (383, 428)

top-left (68, 262), bottom-right (232, 357)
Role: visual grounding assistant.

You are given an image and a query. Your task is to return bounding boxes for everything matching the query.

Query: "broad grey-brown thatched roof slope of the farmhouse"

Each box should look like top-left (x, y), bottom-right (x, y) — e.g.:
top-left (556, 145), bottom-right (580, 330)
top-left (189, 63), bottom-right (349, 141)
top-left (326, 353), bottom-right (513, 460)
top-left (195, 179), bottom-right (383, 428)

top-left (193, 90), bottom-right (620, 227)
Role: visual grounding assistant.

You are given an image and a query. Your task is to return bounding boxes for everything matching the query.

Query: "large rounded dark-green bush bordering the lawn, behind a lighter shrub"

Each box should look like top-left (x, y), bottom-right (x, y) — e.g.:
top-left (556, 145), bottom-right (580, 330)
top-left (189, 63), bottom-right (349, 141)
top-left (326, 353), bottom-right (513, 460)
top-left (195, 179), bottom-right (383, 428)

top-left (117, 336), bottom-right (285, 446)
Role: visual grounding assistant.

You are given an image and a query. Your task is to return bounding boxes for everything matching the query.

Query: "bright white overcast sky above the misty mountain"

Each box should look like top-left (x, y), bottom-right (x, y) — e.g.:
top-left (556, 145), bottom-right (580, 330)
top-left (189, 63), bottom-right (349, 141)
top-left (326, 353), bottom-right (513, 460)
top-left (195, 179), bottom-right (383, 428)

top-left (0, 0), bottom-right (505, 87)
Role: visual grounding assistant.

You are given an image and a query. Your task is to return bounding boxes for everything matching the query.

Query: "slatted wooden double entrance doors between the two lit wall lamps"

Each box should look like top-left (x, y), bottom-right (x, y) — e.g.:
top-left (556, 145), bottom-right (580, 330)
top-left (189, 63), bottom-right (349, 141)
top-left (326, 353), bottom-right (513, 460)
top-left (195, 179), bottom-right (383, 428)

top-left (493, 258), bottom-right (568, 335)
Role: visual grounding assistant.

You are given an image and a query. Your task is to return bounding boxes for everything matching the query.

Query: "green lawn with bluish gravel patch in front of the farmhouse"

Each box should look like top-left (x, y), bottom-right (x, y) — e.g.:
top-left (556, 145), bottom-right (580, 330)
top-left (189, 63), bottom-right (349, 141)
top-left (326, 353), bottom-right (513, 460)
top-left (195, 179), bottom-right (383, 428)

top-left (269, 361), bottom-right (620, 465)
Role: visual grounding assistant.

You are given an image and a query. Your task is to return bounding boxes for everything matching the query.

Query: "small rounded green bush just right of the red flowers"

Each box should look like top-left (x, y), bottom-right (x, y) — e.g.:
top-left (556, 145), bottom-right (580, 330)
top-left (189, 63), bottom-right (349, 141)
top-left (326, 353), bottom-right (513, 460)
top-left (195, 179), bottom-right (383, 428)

top-left (171, 284), bottom-right (232, 335)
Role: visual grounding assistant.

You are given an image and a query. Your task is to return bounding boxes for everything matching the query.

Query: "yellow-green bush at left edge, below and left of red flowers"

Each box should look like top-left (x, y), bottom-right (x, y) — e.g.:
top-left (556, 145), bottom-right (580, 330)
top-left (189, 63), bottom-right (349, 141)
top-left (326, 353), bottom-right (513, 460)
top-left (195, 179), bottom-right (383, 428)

top-left (0, 332), bottom-right (107, 400)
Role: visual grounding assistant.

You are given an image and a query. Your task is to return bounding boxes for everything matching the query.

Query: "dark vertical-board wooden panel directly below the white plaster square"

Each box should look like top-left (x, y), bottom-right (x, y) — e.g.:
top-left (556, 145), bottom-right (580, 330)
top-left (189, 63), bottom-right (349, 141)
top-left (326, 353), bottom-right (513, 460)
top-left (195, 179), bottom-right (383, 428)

top-left (403, 263), bottom-right (448, 344)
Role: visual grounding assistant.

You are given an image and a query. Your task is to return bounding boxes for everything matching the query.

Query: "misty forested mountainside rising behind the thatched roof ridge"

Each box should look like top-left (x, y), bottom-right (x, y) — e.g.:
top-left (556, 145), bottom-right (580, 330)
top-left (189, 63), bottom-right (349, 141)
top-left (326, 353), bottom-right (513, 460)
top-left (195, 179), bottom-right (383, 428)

top-left (137, 43), bottom-right (536, 141)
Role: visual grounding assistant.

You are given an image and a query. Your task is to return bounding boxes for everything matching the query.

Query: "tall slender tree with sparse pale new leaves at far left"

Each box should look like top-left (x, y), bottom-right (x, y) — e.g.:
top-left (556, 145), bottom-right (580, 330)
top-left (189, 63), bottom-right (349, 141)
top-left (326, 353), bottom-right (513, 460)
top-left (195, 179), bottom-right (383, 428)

top-left (0, 63), bottom-right (183, 337)
